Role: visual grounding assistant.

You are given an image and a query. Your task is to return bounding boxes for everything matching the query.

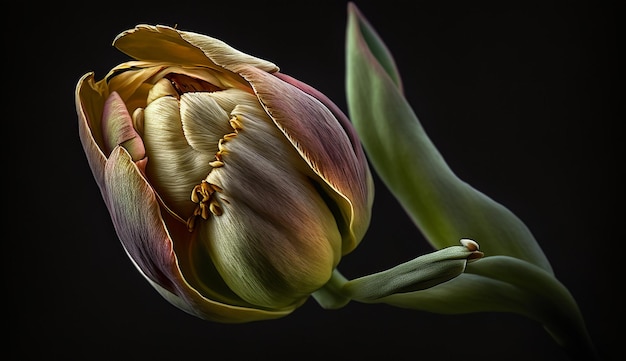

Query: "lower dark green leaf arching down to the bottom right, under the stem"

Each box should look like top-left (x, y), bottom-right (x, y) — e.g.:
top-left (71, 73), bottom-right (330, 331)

top-left (376, 256), bottom-right (597, 360)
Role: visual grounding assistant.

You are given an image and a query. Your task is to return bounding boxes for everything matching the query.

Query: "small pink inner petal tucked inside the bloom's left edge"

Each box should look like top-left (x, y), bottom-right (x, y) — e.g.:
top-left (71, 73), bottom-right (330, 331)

top-left (102, 92), bottom-right (146, 161)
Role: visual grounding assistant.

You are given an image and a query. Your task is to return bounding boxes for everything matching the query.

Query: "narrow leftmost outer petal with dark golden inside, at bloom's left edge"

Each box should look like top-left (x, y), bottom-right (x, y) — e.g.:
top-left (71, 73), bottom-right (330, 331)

top-left (75, 73), bottom-right (106, 192)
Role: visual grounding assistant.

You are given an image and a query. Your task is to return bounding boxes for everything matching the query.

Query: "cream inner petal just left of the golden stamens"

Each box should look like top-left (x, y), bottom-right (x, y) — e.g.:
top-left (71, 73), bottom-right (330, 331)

top-left (143, 97), bottom-right (215, 219)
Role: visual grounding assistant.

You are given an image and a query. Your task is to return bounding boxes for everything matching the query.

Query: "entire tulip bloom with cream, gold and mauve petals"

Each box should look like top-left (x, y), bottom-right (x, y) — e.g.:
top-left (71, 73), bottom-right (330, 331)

top-left (75, 25), bottom-right (373, 323)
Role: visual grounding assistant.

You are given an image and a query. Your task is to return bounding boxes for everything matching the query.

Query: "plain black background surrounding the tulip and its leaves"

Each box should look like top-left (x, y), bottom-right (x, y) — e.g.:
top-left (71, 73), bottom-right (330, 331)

top-left (3, 0), bottom-right (624, 360)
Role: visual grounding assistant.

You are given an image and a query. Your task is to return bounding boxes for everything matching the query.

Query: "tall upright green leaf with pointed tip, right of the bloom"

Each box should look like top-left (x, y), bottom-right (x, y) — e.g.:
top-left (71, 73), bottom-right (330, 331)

top-left (346, 3), bottom-right (552, 273)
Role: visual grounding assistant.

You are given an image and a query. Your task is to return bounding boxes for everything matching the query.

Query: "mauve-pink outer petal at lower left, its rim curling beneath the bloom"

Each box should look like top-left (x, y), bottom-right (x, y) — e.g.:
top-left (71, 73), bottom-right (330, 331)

top-left (104, 147), bottom-right (295, 323)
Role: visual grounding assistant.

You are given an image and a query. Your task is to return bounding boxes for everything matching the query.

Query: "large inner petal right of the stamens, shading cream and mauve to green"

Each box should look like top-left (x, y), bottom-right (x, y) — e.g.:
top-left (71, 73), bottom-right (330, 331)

top-left (196, 101), bottom-right (341, 307)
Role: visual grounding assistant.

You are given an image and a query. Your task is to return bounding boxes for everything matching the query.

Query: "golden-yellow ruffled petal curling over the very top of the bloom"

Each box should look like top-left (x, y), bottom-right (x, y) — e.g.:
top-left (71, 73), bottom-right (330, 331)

top-left (113, 24), bottom-right (278, 71)
